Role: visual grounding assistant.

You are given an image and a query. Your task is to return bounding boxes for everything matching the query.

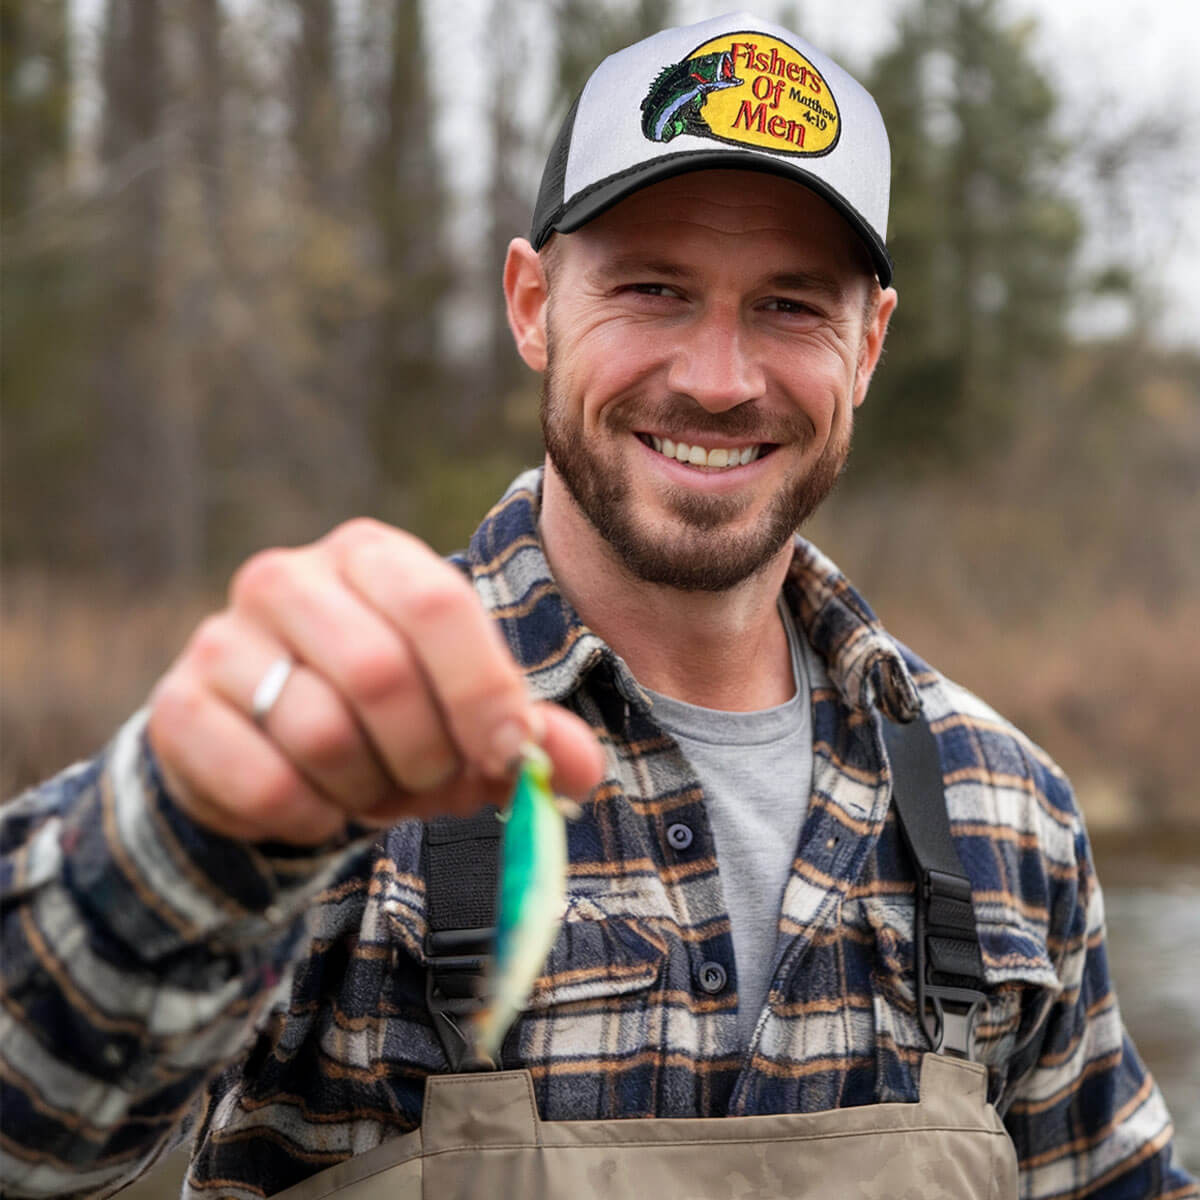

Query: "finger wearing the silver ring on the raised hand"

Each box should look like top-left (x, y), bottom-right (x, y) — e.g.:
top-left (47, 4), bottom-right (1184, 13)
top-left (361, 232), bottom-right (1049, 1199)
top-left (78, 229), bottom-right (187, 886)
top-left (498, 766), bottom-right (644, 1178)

top-left (192, 613), bottom-right (396, 812)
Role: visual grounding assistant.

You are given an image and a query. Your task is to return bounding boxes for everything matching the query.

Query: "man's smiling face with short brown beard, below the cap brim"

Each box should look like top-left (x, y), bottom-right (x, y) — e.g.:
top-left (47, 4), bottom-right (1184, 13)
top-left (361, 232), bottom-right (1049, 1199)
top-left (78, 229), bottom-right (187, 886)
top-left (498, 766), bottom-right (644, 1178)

top-left (542, 172), bottom-right (894, 592)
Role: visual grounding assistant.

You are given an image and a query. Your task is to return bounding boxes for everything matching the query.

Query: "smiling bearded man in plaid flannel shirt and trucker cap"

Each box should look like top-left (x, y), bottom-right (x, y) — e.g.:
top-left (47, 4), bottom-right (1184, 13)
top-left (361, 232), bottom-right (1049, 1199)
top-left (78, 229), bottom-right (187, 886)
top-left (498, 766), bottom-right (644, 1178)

top-left (0, 14), bottom-right (1196, 1198)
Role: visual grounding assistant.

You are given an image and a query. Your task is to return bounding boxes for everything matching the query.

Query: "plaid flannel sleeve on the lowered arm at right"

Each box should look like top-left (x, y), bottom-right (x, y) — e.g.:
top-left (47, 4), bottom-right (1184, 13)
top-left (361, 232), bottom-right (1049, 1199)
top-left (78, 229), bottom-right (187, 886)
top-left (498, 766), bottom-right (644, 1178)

top-left (1006, 776), bottom-right (1200, 1200)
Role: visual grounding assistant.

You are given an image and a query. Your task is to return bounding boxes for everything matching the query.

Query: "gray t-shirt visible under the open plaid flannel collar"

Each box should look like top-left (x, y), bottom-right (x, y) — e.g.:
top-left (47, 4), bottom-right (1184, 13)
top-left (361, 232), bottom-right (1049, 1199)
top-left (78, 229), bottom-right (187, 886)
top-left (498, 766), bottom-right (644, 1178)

top-left (648, 602), bottom-right (812, 1044)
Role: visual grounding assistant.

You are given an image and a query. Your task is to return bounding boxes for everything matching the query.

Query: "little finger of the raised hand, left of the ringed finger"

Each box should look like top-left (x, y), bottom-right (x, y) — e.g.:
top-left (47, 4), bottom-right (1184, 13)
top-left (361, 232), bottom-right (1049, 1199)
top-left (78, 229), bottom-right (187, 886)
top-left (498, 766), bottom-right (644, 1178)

top-left (148, 672), bottom-right (346, 845)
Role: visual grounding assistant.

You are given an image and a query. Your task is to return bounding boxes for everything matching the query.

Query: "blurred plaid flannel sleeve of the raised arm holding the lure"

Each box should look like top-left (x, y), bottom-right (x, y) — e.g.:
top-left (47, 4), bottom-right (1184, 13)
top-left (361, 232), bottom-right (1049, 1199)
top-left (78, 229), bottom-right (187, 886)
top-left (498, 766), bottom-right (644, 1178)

top-left (0, 713), bottom-right (370, 1196)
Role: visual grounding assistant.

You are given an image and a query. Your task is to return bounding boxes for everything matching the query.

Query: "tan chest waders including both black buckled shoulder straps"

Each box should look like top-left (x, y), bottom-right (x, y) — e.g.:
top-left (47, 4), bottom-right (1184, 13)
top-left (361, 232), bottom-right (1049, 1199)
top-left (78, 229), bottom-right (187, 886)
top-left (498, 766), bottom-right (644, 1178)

top-left (278, 720), bottom-right (1016, 1200)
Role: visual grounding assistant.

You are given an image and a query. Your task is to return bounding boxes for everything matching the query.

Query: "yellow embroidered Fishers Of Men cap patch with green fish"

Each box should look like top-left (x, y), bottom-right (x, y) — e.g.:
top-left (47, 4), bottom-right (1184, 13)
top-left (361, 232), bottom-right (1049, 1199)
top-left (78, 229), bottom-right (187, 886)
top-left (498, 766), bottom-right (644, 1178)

top-left (642, 32), bottom-right (841, 156)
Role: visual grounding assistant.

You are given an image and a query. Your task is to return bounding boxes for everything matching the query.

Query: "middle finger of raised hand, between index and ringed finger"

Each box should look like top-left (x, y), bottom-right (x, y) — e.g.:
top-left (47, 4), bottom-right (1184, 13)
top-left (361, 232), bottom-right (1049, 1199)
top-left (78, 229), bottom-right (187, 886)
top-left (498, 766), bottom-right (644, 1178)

top-left (234, 551), bottom-right (460, 791)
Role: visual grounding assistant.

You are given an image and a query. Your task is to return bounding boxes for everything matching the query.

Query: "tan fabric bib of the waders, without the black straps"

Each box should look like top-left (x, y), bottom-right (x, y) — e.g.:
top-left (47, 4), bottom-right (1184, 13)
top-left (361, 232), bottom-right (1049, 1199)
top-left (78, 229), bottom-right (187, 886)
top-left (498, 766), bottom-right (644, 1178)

top-left (270, 1054), bottom-right (1016, 1200)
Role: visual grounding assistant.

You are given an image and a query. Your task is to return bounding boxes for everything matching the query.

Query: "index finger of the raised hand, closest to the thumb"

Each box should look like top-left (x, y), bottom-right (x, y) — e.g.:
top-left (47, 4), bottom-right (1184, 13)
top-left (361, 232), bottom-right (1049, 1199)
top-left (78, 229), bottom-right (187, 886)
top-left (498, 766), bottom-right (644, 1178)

top-left (337, 536), bottom-right (545, 779)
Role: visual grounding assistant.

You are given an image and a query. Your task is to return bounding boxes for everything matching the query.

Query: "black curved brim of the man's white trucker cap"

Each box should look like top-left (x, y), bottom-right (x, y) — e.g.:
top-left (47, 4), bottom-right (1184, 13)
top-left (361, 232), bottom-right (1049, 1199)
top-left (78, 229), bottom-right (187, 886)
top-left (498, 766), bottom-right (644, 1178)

top-left (533, 150), bottom-right (892, 288)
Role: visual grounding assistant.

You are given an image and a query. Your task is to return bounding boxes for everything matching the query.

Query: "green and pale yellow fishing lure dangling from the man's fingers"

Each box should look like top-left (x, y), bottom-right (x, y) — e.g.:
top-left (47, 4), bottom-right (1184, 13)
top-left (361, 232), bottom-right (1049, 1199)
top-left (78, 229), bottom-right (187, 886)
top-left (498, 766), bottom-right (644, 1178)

top-left (473, 745), bottom-right (577, 1060)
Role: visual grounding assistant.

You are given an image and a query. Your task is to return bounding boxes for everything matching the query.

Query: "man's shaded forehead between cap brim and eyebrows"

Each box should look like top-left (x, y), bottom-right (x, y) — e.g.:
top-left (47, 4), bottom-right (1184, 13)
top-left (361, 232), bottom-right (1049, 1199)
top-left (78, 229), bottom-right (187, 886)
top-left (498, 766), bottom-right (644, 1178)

top-left (560, 170), bottom-right (875, 281)
